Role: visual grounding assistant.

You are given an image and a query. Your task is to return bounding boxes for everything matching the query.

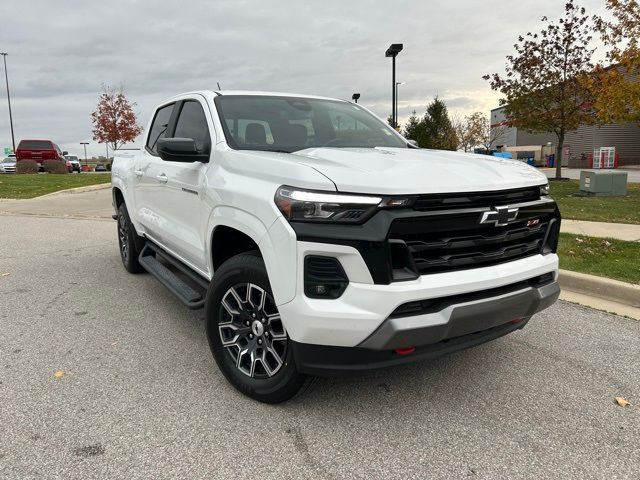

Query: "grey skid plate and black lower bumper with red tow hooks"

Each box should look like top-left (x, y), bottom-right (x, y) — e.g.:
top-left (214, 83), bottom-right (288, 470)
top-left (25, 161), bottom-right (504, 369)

top-left (292, 280), bottom-right (560, 375)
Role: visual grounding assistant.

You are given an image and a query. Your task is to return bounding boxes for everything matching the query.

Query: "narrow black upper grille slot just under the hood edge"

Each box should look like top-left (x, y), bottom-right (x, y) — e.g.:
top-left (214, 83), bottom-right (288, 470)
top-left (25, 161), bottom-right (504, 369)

top-left (413, 187), bottom-right (540, 211)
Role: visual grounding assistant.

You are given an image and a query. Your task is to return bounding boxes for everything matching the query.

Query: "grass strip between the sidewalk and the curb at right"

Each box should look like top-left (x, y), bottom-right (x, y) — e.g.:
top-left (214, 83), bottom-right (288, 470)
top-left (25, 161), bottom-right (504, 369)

top-left (558, 233), bottom-right (640, 284)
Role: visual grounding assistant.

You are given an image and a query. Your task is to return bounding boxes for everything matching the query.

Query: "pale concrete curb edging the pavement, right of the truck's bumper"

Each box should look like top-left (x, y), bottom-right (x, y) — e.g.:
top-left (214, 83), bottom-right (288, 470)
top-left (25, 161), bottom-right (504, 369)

top-left (558, 270), bottom-right (640, 308)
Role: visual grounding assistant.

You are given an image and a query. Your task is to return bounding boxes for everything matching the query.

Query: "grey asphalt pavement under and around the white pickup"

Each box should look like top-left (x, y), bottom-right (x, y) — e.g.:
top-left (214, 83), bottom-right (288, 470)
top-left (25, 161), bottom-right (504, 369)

top-left (0, 213), bottom-right (640, 479)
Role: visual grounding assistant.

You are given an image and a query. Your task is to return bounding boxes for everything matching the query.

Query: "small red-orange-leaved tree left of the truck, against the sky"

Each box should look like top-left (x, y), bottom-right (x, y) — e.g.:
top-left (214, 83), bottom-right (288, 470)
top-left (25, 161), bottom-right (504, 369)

top-left (91, 85), bottom-right (142, 150)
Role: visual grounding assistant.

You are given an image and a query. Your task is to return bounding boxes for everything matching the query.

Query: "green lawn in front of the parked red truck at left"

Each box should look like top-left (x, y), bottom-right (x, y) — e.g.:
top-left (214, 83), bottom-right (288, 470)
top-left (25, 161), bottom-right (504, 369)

top-left (0, 172), bottom-right (111, 198)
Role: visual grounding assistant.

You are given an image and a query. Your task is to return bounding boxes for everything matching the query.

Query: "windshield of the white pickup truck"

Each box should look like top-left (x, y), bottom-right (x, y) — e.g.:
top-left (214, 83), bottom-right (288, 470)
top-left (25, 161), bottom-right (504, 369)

top-left (215, 95), bottom-right (407, 152)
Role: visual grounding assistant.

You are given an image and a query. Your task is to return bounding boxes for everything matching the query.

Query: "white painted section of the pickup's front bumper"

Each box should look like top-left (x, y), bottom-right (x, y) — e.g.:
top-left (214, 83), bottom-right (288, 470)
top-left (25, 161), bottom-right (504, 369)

top-left (278, 246), bottom-right (558, 348)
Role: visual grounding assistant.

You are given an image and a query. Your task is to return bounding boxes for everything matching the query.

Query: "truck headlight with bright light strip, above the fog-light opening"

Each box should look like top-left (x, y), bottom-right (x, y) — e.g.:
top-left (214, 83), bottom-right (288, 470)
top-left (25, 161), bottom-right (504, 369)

top-left (274, 187), bottom-right (411, 223)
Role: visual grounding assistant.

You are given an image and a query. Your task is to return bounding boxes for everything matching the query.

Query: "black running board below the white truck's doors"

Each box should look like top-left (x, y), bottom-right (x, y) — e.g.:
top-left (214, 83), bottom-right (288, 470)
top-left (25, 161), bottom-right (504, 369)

top-left (138, 246), bottom-right (208, 310)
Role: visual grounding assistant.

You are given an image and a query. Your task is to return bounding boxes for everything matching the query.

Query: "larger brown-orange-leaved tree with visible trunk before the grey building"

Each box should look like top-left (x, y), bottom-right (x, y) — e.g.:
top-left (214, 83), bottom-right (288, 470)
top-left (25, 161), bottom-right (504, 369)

top-left (483, 0), bottom-right (595, 179)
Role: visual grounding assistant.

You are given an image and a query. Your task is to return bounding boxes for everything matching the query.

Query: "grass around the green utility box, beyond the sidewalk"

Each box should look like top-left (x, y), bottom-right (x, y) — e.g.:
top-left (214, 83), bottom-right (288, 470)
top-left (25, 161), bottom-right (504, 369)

top-left (550, 180), bottom-right (640, 224)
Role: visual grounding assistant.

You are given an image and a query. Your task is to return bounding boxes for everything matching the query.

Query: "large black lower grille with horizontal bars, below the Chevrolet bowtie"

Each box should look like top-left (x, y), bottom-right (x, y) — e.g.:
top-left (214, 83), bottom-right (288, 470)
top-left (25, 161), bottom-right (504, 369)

top-left (389, 205), bottom-right (555, 275)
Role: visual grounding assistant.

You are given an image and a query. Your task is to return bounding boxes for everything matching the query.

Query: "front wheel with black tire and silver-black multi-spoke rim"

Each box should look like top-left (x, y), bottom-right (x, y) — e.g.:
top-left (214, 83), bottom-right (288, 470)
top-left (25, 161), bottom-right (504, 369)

top-left (205, 254), bottom-right (310, 403)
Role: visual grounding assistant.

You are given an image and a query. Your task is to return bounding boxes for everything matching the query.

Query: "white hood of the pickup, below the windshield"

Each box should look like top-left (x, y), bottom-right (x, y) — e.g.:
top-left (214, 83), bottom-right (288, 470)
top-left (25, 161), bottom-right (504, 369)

top-left (291, 147), bottom-right (547, 195)
